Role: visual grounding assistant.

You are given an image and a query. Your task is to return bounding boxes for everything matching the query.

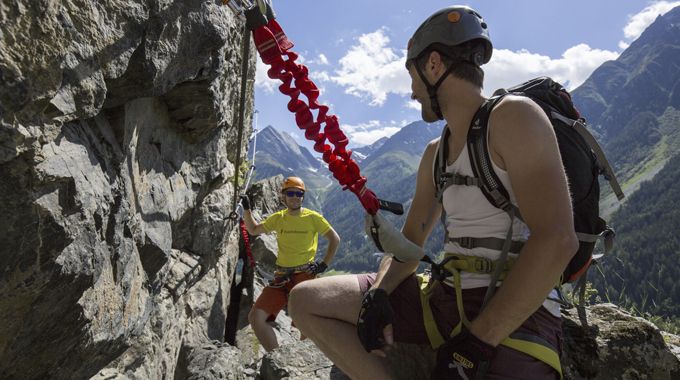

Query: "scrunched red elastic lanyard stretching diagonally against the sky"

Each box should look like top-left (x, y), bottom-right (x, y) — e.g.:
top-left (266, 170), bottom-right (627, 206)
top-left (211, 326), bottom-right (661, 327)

top-left (253, 20), bottom-right (380, 215)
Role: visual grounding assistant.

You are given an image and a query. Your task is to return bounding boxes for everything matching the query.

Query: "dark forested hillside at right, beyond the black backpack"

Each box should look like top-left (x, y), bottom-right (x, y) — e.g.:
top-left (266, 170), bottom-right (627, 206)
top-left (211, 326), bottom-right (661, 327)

top-left (590, 151), bottom-right (680, 317)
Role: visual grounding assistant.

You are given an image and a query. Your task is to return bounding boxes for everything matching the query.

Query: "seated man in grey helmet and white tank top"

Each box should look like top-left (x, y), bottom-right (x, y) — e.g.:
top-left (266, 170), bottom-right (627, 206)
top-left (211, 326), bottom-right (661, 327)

top-left (289, 6), bottom-right (578, 379)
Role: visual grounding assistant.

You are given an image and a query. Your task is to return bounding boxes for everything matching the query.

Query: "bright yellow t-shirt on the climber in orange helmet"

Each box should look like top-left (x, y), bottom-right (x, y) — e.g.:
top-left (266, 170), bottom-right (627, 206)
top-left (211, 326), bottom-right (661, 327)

top-left (262, 208), bottom-right (331, 267)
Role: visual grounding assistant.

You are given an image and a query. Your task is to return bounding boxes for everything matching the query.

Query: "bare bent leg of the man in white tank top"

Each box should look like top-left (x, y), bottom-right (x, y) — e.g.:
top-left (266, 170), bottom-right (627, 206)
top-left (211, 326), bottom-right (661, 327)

top-left (288, 275), bottom-right (391, 379)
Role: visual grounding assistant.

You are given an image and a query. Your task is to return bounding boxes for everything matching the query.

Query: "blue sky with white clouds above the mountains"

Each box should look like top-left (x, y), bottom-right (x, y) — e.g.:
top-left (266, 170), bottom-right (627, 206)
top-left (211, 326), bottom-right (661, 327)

top-left (255, 0), bottom-right (680, 147)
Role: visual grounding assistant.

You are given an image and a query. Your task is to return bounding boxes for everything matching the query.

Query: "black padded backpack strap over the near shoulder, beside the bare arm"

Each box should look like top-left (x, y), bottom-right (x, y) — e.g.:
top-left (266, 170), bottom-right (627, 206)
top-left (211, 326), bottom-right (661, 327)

top-left (467, 92), bottom-right (521, 219)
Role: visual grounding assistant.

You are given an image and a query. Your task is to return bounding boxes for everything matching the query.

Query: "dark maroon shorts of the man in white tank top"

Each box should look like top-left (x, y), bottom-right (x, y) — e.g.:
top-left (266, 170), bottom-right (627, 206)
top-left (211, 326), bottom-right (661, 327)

top-left (357, 273), bottom-right (562, 380)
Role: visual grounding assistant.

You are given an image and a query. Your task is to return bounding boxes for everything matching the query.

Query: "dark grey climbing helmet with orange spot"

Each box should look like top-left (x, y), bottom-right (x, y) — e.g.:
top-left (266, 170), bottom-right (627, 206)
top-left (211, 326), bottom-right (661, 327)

top-left (406, 5), bottom-right (493, 66)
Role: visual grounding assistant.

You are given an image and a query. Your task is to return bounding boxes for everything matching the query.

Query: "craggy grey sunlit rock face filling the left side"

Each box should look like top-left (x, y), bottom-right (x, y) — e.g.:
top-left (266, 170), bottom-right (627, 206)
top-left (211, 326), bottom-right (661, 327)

top-left (0, 0), bottom-right (255, 379)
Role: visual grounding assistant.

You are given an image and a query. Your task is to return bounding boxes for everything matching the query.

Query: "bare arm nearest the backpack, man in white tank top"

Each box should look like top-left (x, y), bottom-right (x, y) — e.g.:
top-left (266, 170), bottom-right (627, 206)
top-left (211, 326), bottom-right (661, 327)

top-left (470, 97), bottom-right (578, 345)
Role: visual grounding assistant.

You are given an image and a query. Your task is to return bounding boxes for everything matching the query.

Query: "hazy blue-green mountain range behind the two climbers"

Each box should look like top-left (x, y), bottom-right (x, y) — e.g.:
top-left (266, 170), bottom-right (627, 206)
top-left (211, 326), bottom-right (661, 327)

top-left (256, 7), bottom-right (680, 318)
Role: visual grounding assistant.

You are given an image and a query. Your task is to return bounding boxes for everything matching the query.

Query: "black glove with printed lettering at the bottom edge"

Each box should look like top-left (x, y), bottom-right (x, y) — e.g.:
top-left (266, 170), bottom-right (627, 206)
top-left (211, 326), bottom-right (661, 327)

top-left (432, 329), bottom-right (495, 380)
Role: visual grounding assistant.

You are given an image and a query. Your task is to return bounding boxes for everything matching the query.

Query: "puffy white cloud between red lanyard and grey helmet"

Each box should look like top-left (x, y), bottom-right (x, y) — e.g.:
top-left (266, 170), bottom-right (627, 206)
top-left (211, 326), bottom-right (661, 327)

top-left (331, 29), bottom-right (411, 106)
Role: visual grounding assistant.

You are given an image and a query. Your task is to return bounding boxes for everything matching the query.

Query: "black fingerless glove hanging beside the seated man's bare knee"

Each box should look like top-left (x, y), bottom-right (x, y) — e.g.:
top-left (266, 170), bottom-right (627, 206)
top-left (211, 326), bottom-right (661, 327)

top-left (357, 288), bottom-right (393, 352)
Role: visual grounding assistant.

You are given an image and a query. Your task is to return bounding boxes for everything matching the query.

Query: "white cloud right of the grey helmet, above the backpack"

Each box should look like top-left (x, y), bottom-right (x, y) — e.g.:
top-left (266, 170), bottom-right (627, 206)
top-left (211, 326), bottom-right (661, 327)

top-left (484, 44), bottom-right (619, 96)
